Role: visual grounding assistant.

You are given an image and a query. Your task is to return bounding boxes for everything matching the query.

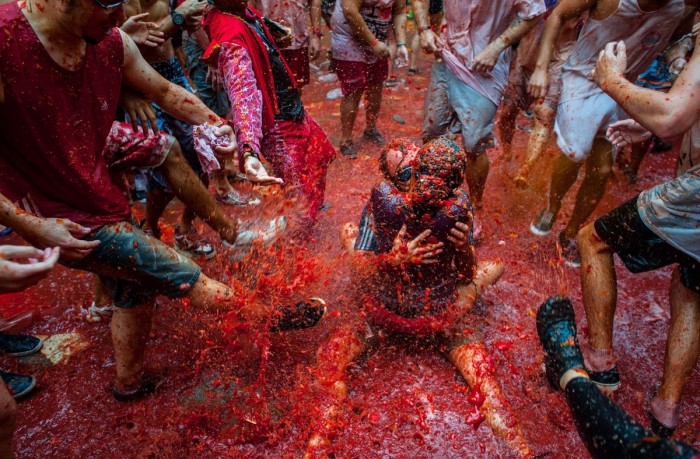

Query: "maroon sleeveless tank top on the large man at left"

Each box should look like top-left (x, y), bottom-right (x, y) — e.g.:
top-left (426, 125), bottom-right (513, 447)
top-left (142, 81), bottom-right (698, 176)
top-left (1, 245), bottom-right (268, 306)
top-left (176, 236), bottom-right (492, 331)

top-left (0, 2), bottom-right (130, 229)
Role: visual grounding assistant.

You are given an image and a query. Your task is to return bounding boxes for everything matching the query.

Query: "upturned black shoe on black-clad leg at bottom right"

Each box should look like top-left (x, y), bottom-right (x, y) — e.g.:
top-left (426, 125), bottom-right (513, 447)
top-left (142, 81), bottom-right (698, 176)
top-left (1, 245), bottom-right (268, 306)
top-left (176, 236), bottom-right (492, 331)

top-left (537, 296), bottom-right (584, 389)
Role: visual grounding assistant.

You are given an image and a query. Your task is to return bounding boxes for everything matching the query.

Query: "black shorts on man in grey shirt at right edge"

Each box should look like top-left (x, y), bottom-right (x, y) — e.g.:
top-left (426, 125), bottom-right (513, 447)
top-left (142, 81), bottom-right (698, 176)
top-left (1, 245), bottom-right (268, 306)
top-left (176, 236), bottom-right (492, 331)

top-left (595, 196), bottom-right (700, 292)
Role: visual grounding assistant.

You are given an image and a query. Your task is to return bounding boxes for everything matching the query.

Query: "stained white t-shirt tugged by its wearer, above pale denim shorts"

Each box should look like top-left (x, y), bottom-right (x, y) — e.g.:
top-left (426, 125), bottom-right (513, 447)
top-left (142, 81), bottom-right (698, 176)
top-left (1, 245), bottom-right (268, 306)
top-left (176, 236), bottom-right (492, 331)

top-left (442, 0), bottom-right (546, 105)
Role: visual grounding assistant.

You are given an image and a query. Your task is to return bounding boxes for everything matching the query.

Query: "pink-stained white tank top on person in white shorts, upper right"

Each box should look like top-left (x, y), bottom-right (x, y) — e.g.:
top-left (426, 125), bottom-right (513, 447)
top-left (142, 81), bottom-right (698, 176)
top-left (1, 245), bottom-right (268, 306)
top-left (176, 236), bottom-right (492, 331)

top-left (560, 0), bottom-right (685, 102)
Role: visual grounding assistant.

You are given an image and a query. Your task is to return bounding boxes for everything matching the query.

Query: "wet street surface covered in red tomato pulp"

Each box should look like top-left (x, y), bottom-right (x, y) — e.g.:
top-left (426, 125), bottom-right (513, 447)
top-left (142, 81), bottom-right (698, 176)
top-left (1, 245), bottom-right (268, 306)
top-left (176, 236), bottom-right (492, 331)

top-left (0, 48), bottom-right (700, 458)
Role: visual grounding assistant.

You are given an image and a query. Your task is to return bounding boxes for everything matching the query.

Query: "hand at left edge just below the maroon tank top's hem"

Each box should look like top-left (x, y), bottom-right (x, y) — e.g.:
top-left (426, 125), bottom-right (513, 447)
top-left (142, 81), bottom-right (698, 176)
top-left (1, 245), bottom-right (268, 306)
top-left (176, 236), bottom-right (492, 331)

top-left (13, 217), bottom-right (100, 260)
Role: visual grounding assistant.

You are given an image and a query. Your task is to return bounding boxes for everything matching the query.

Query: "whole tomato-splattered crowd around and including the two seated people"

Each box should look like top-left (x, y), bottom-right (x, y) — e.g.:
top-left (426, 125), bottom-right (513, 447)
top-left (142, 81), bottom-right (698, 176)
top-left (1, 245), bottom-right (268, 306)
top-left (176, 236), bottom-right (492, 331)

top-left (0, 0), bottom-right (700, 457)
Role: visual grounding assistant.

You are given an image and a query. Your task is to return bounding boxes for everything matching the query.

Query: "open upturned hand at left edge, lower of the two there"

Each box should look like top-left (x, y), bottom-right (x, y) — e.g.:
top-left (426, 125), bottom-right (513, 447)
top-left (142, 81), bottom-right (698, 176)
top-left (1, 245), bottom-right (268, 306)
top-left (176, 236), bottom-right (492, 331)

top-left (0, 245), bottom-right (61, 293)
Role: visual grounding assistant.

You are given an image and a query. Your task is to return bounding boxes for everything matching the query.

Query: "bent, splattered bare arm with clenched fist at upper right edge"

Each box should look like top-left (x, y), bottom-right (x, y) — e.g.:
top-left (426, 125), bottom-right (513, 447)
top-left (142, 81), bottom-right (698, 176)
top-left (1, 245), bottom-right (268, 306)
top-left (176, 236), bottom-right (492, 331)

top-left (595, 38), bottom-right (700, 137)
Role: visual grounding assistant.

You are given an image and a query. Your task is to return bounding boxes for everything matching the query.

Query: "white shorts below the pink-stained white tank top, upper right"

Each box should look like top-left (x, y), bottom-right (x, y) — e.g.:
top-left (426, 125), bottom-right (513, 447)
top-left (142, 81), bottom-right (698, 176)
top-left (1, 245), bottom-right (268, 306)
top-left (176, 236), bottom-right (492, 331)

top-left (554, 93), bottom-right (629, 163)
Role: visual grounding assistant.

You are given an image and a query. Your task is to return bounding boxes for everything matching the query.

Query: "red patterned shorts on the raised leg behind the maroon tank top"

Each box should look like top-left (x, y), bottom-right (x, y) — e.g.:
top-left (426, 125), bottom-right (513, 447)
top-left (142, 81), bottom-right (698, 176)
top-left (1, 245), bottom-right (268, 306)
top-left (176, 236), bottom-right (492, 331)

top-left (102, 121), bottom-right (175, 172)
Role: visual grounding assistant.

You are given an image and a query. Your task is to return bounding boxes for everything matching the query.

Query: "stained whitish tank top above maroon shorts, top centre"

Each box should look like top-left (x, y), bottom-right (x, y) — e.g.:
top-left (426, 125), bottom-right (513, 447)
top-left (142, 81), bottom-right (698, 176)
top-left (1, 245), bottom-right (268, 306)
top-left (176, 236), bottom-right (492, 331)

top-left (331, 0), bottom-right (394, 64)
